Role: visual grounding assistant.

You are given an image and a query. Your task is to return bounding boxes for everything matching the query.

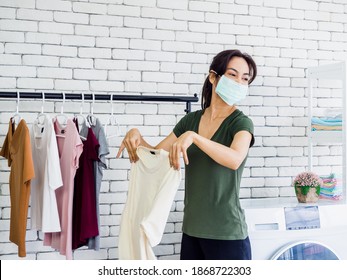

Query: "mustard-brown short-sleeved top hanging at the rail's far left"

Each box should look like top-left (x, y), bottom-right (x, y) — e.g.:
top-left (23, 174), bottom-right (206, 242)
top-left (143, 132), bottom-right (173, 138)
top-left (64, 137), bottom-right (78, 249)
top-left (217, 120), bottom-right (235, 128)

top-left (0, 118), bottom-right (35, 257)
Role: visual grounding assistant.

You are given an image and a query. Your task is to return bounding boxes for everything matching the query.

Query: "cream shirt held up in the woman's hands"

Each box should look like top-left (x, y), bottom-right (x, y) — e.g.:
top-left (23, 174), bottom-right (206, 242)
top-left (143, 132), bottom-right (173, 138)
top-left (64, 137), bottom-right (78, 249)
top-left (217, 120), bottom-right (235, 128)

top-left (118, 147), bottom-right (181, 260)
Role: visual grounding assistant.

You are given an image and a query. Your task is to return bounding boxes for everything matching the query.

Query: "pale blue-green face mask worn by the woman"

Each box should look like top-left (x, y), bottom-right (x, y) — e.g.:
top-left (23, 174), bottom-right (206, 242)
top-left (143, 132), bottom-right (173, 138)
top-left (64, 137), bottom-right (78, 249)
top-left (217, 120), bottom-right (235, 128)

top-left (216, 75), bottom-right (248, 106)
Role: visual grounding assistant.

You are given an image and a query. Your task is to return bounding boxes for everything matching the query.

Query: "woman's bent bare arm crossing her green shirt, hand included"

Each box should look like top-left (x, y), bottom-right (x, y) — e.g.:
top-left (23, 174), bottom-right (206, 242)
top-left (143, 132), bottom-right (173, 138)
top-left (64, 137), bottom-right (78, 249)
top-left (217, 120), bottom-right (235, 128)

top-left (169, 130), bottom-right (252, 170)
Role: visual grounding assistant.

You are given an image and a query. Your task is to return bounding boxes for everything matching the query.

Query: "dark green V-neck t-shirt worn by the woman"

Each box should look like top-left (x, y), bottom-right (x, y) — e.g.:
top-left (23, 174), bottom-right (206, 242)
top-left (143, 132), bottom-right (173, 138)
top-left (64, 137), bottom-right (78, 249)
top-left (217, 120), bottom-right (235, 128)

top-left (173, 109), bottom-right (254, 240)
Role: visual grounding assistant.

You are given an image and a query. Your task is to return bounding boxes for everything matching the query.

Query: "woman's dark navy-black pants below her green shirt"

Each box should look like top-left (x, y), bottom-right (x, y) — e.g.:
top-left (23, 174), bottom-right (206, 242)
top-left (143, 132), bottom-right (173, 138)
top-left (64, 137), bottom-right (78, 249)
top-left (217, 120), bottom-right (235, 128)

top-left (180, 233), bottom-right (252, 260)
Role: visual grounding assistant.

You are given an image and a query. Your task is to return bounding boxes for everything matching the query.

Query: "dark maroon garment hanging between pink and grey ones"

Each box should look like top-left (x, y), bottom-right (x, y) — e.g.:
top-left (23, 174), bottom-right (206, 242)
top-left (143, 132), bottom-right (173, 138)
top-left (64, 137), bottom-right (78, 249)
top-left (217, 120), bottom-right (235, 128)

top-left (72, 119), bottom-right (100, 250)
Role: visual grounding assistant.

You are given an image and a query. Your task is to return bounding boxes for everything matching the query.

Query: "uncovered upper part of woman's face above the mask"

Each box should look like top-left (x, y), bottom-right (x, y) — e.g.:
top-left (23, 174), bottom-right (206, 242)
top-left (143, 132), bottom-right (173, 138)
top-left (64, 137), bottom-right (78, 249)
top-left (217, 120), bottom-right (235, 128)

top-left (224, 56), bottom-right (251, 85)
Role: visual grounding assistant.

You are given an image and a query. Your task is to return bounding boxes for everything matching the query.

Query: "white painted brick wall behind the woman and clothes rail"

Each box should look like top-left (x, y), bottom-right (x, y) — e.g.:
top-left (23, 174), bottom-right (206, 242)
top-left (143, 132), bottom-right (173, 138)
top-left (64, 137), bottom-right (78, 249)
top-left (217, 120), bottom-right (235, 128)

top-left (0, 0), bottom-right (347, 259)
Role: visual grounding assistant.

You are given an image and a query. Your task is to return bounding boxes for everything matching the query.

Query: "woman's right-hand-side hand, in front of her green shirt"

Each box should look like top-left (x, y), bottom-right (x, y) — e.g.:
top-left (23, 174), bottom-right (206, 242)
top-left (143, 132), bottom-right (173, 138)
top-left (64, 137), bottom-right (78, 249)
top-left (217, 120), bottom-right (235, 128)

top-left (169, 131), bottom-right (197, 170)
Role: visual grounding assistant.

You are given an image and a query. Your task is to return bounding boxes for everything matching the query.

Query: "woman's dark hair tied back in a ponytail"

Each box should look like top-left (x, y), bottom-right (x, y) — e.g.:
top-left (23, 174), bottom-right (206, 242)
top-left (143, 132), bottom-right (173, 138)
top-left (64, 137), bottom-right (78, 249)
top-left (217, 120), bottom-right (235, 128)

top-left (201, 50), bottom-right (257, 109)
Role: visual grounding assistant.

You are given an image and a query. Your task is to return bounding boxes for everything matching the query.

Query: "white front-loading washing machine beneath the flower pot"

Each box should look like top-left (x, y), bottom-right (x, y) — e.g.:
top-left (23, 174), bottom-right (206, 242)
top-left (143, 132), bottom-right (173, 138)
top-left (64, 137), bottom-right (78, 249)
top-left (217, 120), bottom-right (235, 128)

top-left (241, 197), bottom-right (347, 260)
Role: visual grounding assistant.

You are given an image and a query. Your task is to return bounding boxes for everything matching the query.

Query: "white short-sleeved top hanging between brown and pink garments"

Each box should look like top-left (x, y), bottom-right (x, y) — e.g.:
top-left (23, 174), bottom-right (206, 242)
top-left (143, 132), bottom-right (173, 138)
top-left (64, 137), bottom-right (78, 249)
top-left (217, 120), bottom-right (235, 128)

top-left (30, 115), bottom-right (63, 232)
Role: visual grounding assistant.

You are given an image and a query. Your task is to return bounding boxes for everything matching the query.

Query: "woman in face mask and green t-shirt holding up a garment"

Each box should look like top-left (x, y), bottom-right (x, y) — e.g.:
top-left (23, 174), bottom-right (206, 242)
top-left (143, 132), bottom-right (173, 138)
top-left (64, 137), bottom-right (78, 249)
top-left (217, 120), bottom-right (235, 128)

top-left (117, 50), bottom-right (257, 260)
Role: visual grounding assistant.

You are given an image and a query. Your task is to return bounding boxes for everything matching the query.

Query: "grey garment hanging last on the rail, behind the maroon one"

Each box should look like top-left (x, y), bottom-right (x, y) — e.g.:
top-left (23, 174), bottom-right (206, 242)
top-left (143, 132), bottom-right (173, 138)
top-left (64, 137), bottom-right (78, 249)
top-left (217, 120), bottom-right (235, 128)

top-left (88, 118), bottom-right (110, 251)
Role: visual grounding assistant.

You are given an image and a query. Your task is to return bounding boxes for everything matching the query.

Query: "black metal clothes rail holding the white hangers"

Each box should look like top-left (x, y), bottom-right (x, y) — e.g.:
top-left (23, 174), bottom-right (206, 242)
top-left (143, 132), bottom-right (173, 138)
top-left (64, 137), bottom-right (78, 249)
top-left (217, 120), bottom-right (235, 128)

top-left (0, 91), bottom-right (199, 113)
